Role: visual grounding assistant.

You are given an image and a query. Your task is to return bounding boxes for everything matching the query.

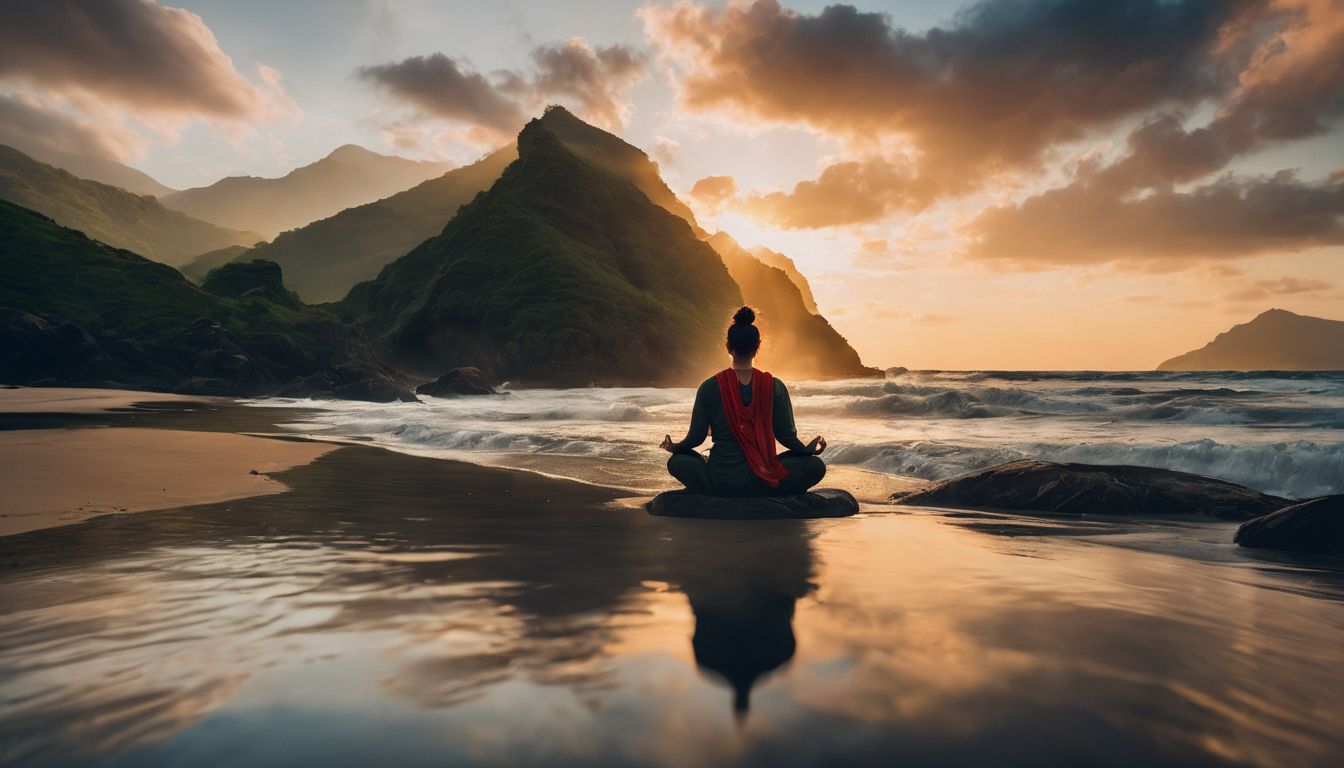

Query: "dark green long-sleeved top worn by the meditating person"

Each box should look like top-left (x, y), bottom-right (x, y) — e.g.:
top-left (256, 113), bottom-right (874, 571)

top-left (672, 377), bottom-right (808, 487)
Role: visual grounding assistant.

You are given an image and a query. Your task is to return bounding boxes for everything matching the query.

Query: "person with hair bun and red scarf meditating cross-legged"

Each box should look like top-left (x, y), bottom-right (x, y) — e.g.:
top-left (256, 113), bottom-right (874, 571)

top-left (661, 307), bottom-right (827, 496)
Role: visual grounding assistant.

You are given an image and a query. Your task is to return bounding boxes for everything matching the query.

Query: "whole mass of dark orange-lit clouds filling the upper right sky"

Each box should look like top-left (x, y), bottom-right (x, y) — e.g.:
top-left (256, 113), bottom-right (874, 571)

top-left (640, 0), bottom-right (1344, 252)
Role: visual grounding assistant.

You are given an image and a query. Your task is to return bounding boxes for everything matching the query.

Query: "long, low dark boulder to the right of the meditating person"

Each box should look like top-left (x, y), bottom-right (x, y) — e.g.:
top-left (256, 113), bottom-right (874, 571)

top-left (891, 461), bottom-right (1292, 521)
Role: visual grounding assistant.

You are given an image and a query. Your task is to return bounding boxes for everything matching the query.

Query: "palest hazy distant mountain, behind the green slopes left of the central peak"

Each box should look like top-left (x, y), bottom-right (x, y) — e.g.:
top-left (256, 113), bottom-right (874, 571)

top-left (163, 144), bottom-right (452, 239)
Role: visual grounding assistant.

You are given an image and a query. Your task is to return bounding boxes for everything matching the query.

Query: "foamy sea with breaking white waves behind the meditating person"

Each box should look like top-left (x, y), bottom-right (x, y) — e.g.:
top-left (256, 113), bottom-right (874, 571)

top-left (249, 371), bottom-right (1344, 498)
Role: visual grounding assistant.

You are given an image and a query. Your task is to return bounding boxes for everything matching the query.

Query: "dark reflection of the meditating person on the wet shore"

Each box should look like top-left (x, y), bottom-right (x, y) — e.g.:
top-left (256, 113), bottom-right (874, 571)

top-left (675, 521), bottom-right (814, 717)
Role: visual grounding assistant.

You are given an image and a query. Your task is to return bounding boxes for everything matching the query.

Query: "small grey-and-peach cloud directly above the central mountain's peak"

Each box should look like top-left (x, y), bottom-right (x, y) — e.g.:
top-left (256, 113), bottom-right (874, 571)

top-left (356, 38), bottom-right (646, 140)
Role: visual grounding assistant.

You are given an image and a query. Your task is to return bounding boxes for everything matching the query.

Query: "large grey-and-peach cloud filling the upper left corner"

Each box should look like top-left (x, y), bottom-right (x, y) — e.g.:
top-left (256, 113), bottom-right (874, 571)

top-left (0, 0), bottom-right (302, 160)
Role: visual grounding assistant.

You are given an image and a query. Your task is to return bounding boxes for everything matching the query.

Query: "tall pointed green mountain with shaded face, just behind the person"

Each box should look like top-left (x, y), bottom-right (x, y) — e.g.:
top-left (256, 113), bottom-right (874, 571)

top-left (336, 109), bottom-right (742, 386)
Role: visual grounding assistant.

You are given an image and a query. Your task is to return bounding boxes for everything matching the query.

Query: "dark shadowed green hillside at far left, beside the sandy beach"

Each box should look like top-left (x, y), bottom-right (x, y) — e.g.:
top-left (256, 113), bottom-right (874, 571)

top-left (0, 202), bottom-right (407, 401)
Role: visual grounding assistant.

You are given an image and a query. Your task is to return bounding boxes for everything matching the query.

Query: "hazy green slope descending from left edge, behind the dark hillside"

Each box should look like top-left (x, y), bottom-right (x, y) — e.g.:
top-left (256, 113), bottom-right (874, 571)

top-left (0, 145), bottom-right (262, 265)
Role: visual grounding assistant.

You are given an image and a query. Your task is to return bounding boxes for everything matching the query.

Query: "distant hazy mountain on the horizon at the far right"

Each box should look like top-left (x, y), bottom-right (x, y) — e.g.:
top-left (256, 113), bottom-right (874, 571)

top-left (1157, 309), bottom-right (1344, 371)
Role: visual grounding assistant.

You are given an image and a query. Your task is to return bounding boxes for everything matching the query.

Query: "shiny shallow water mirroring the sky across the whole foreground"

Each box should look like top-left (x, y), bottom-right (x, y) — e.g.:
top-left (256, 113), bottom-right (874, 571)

top-left (0, 448), bottom-right (1344, 767)
